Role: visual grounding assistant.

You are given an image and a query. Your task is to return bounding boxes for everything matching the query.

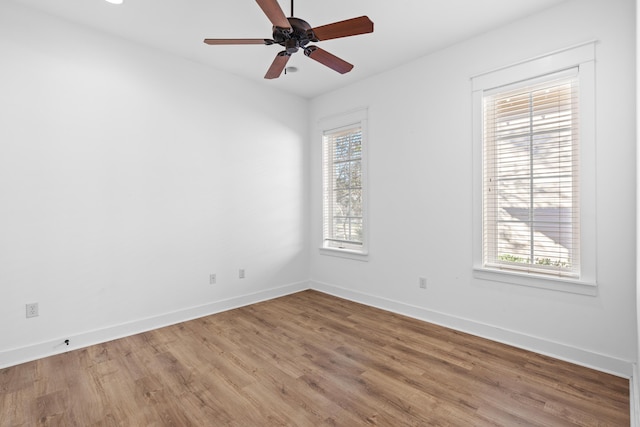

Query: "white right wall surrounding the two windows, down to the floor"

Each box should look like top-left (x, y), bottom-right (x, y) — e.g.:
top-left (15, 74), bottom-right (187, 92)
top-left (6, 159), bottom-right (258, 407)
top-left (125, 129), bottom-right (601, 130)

top-left (311, 0), bottom-right (637, 375)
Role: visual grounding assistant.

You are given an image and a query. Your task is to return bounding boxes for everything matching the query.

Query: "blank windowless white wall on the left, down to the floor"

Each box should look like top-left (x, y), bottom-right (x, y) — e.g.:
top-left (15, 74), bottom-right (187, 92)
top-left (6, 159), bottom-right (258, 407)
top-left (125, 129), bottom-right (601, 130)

top-left (0, 2), bottom-right (309, 367)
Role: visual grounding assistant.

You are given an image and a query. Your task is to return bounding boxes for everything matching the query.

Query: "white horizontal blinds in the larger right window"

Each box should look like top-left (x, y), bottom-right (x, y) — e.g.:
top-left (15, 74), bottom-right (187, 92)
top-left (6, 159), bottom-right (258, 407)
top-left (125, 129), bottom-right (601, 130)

top-left (482, 70), bottom-right (580, 277)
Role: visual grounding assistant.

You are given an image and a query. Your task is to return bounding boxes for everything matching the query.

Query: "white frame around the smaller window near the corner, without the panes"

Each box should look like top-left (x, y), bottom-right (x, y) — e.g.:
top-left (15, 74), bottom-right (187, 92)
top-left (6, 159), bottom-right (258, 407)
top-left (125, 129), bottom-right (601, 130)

top-left (318, 109), bottom-right (369, 261)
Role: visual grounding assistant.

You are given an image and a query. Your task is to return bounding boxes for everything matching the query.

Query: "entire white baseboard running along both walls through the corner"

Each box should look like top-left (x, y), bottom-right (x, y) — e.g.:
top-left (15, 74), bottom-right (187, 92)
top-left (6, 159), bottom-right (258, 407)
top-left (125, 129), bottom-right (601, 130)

top-left (0, 282), bottom-right (640, 384)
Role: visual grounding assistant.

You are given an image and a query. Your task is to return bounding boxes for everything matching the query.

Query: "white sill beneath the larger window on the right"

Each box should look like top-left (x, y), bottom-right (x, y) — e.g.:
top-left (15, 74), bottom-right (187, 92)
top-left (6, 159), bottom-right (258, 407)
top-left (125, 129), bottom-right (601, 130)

top-left (473, 267), bottom-right (598, 296)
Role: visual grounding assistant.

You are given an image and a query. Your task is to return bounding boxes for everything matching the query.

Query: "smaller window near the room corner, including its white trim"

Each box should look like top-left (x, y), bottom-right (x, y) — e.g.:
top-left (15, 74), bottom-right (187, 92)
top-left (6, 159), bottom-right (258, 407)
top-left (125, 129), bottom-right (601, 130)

top-left (322, 109), bottom-right (366, 255)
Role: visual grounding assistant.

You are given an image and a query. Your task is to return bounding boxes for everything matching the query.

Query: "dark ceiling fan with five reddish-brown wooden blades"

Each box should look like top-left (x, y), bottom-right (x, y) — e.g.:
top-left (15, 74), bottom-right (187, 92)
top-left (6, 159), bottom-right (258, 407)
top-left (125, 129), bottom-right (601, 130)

top-left (204, 0), bottom-right (373, 79)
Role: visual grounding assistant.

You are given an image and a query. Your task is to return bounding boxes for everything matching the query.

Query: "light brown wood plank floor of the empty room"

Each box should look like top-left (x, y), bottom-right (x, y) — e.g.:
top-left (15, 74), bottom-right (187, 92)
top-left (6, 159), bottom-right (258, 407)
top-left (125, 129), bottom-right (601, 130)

top-left (0, 291), bottom-right (630, 427)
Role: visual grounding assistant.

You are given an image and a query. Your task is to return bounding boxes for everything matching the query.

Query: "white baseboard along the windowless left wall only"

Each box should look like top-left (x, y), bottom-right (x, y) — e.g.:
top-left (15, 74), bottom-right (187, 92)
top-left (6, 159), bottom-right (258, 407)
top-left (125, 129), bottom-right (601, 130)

top-left (0, 282), bottom-right (309, 369)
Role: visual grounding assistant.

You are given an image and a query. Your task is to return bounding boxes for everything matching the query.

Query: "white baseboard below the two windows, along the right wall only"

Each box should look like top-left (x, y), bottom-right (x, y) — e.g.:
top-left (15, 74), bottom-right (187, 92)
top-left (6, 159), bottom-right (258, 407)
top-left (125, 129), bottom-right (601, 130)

top-left (311, 282), bottom-right (640, 380)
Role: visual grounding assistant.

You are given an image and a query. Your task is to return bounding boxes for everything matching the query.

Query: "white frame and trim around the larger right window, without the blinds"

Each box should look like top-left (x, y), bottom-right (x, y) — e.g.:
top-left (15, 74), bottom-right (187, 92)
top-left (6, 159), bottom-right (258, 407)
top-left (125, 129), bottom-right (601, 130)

top-left (471, 42), bottom-right (597, 295)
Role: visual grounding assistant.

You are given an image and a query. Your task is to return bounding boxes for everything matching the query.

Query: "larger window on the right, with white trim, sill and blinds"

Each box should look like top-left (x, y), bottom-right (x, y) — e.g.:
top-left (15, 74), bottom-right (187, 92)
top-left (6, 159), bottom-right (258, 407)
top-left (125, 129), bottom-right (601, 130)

top-left (473, 44), bottom-right (595, 294)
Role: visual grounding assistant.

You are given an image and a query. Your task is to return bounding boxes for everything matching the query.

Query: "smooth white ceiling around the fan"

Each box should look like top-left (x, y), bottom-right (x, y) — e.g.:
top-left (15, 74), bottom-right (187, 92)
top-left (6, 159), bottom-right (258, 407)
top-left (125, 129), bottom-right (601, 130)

top-left (14, 0), bottom-right (565, 98)
